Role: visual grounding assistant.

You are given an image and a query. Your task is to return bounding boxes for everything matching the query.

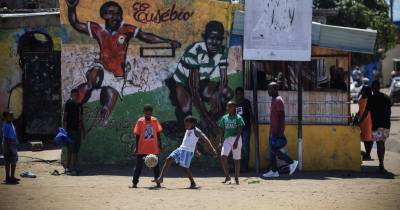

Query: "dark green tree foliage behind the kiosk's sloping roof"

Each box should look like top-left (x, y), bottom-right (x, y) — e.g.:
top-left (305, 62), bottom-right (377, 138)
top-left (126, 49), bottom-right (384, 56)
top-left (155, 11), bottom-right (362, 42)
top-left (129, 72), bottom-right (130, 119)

top-left (313, 0), bottom-right (397, 65)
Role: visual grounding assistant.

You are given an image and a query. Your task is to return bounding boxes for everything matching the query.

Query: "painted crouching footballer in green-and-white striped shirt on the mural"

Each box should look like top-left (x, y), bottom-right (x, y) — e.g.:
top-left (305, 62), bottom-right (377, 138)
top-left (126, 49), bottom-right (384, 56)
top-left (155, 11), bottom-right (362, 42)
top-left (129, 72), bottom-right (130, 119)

top-left (166, 21), bottom-right (233, 134)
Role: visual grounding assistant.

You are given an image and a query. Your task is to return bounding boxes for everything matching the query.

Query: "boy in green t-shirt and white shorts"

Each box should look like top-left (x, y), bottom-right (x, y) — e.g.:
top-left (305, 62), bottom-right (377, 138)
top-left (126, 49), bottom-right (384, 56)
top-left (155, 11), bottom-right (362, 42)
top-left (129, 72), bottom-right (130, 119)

top-left (218, 101), bottom-right (245, 184)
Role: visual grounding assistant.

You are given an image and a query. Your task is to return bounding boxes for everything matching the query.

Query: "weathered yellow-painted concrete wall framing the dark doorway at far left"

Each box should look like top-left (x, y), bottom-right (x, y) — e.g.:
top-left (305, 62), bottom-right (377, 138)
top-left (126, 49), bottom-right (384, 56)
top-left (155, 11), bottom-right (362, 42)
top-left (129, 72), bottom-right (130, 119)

top-left (0, 16), bottom-right (61, 139)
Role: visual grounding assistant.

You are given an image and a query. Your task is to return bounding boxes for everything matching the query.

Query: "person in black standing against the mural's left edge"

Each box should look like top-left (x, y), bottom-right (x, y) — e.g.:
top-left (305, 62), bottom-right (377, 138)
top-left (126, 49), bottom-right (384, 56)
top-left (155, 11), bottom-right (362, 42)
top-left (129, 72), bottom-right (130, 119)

top-left (64, 89), bottom-right (84, 175)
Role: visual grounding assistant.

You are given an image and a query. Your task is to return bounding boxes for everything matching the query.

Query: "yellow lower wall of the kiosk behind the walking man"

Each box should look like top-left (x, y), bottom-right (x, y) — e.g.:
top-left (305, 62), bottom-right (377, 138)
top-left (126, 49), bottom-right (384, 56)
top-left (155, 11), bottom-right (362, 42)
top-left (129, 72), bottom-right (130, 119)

top-left (250, 125), bottom-right (361, 171)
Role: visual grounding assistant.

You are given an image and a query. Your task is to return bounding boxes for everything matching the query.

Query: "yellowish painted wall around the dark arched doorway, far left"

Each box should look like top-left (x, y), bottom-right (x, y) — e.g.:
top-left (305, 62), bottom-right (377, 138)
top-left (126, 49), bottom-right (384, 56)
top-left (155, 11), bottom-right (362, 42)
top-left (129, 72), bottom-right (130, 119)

top-left (0, 26), bottom-right (61, 139)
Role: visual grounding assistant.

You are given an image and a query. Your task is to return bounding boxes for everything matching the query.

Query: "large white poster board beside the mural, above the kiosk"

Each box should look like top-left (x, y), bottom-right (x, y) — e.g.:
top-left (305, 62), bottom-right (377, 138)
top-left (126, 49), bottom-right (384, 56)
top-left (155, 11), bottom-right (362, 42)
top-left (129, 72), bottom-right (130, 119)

top-left (244, 0), bottom-right (312, 61)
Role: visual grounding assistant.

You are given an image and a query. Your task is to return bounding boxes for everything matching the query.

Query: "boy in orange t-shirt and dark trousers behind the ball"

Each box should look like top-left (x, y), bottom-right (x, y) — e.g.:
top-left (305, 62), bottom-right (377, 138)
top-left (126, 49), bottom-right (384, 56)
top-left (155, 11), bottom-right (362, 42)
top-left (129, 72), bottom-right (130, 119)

top-left (132, 105), bottom-right (162, 188)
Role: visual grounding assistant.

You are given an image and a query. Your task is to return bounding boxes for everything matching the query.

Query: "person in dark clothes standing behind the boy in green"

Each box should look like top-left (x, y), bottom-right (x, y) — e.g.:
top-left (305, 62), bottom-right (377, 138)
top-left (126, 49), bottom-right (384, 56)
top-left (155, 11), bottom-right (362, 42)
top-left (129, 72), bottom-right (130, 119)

top-left (235, 87), bottom-right (254, 172)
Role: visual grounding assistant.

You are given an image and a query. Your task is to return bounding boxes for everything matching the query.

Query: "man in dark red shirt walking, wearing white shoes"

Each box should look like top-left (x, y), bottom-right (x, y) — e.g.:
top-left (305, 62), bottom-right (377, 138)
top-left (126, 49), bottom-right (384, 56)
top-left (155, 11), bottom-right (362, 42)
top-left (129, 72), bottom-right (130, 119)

top-left (263, 82), bottom-right (298, 178)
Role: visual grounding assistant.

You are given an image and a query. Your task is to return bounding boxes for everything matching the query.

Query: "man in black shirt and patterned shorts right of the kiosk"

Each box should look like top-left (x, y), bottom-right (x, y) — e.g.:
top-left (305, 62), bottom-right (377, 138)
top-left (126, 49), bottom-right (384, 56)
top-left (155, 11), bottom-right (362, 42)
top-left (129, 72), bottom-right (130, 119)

top-left (361, 80), bottom-right (392, 173)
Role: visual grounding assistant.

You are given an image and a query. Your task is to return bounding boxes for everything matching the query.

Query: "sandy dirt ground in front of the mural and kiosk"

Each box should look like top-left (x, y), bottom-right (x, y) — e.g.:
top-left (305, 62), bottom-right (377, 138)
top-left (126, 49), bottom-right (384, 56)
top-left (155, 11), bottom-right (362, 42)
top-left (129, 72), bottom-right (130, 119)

top-left (0, 102), bottom-right (400, 210)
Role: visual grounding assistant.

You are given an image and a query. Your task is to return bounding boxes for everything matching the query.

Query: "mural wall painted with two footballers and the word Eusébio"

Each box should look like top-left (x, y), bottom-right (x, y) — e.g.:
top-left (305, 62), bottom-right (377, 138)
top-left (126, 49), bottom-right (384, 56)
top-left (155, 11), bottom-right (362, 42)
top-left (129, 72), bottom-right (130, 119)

top-left (61, 0), bottom-right (242, 163)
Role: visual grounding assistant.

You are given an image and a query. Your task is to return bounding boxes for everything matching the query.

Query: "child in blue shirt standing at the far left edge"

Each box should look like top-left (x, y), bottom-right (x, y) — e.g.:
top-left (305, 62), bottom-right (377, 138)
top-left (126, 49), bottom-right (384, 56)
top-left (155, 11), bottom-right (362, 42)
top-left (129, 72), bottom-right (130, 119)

top-left (3, 111), bottom-right (19, 184)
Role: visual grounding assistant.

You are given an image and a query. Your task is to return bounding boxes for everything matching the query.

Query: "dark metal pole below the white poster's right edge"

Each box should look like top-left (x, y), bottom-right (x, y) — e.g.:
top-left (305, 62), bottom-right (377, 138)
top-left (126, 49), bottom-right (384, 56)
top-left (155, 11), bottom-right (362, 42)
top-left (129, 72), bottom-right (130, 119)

top-left (295, 62), bottom-right (303, 171)
